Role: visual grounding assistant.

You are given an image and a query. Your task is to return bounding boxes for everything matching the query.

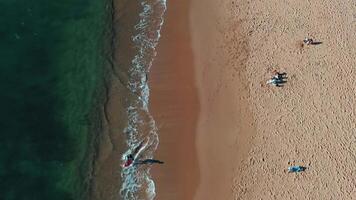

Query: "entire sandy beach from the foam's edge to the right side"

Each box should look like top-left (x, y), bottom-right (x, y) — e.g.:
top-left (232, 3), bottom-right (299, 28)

top-left (150, 0), bottom-right (356, 200)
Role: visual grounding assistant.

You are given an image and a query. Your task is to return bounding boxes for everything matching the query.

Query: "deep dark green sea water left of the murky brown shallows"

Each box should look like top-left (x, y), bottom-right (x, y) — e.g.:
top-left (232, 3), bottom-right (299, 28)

top-left (0, 0), bottom-right (108, 200)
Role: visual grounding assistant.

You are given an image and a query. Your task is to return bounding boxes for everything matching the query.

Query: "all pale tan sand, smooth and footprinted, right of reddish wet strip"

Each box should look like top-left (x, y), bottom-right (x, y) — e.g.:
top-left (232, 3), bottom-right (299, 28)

top-left (192, 1), bottom-right (356, 199)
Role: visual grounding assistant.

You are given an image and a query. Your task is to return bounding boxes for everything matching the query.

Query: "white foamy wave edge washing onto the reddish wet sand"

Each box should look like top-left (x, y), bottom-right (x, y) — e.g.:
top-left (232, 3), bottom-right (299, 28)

top-left (120, 0), bottom-right (167, 200)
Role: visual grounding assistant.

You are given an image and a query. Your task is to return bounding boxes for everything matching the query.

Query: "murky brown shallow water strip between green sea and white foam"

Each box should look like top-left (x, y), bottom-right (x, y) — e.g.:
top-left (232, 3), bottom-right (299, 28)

top-left (90, 0), bottom-right (139, 200)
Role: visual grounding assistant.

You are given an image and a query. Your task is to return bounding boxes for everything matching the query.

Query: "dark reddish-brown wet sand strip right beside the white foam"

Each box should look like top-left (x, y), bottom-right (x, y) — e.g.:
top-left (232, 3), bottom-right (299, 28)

top-left (149, 0), bottom-right (199, 200)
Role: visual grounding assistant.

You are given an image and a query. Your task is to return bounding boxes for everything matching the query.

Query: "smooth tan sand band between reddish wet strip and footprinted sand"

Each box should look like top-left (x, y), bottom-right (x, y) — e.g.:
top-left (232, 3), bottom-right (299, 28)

top-left (191, 0), bottom-right (256, 200)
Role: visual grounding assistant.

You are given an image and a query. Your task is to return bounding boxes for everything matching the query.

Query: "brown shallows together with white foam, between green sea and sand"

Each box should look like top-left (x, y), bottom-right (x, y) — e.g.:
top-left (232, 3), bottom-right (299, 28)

top-left (91, 0), bottom-right (165, 200)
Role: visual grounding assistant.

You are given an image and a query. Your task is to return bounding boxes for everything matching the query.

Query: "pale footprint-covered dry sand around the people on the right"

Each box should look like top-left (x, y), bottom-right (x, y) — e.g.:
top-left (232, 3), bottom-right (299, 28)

top-left (230, 0), bottom-right (356, 199)
